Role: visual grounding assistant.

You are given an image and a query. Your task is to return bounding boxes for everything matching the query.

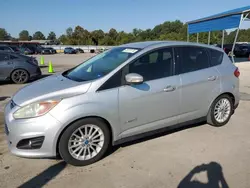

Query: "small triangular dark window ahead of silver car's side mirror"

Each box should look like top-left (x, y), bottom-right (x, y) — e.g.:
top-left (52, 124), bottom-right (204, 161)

top-left (98, 70), bottom-right (122, 91)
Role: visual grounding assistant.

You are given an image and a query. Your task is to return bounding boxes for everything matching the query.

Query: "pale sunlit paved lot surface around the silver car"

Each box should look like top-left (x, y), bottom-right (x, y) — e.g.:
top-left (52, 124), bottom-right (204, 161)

top-left (0, 54), bottom-right (250, 188)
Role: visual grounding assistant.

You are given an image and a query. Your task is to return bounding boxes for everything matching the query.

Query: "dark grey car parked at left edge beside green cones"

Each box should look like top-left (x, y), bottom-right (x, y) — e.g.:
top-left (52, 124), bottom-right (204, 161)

top-left (0, 51), bottom-right (41, 84)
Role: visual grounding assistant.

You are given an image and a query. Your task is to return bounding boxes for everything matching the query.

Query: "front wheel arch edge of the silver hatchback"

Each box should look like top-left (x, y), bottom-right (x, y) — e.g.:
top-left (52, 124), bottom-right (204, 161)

top-left (56, 116), bottom-right (114, 155)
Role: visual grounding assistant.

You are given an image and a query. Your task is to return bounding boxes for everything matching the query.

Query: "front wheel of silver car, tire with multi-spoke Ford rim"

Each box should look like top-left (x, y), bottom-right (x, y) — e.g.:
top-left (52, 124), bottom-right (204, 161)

top-left (59, 118), bottom-right (110, 166)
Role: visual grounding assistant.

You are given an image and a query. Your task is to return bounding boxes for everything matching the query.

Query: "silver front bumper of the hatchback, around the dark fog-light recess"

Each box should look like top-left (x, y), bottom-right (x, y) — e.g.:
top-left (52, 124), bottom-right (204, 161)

top-left (5, 100), bottom-right (61, 158)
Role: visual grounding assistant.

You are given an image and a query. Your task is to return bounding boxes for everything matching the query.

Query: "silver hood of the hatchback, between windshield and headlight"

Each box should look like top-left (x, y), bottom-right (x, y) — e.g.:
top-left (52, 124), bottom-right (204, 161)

top-left (12, 74), bottom-right (91, 106)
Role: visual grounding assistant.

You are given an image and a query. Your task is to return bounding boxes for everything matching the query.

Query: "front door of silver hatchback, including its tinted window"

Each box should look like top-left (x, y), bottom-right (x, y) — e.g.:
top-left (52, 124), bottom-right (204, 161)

top-left (119, 48), bottom-right (180, 137)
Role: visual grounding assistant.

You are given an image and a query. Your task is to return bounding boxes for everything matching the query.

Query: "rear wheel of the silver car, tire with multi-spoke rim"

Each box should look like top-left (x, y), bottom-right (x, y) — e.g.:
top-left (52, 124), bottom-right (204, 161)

top-left (207, 94), bottom-right (233, 127)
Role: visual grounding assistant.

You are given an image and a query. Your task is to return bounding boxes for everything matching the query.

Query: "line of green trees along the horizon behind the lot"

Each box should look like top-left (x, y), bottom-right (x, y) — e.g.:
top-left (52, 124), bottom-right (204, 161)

top-left (0, 20), bottom-right (250, 45)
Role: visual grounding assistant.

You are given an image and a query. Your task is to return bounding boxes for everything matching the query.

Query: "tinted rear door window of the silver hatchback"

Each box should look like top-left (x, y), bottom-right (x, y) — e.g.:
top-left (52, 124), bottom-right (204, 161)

top-left (176, 47), bottom-right (209, 73)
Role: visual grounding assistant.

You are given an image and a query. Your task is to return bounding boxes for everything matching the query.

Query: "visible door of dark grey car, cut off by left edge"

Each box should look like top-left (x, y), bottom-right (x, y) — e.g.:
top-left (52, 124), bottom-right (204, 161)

top-left (0, 53), bottom-right (13, 80)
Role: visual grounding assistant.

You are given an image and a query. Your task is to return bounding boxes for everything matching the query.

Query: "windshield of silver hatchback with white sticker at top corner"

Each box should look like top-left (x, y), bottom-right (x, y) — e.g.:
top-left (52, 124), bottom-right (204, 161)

top-left (63, 47), bottom-right (139, 82)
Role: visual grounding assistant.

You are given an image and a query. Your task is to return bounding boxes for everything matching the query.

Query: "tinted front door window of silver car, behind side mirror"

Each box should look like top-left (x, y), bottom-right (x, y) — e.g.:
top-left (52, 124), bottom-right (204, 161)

top-left (129, 48), bottom-right (173, 81)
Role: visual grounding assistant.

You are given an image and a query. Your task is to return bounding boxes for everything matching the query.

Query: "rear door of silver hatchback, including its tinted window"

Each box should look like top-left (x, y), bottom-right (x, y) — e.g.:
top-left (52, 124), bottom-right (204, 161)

top-left (175, 46), bottom-right (220, 122)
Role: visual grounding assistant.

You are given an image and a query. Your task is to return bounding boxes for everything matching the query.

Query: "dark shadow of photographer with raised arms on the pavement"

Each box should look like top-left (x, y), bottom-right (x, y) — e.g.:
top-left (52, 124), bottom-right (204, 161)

top-left (178, 162), bottom-right (229, 188)
